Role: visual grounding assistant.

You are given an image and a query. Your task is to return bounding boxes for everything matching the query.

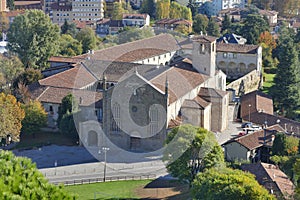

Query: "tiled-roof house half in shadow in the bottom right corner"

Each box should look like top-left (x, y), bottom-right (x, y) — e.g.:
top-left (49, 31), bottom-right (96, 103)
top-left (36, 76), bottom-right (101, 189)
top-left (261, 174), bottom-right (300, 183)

top-left (241, 162), bottom-right (295, 199)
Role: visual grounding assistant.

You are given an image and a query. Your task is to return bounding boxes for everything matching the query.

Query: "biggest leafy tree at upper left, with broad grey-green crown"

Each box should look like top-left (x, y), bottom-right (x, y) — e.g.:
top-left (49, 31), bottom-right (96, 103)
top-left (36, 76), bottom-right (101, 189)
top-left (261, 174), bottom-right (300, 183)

top-left (7, 10), bottom-right (59, 69)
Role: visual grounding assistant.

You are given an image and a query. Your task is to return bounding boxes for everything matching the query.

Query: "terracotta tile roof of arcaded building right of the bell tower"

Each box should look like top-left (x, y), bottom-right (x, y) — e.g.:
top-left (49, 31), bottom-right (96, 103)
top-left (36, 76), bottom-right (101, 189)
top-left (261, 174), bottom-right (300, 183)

top-left (217, 43), bottom-right (259, 54)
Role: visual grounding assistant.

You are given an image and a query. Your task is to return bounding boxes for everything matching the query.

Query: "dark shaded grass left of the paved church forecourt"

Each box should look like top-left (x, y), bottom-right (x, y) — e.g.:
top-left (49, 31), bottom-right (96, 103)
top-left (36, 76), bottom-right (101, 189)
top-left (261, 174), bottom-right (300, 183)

top-left (15, 131), bottom-right (76, 149)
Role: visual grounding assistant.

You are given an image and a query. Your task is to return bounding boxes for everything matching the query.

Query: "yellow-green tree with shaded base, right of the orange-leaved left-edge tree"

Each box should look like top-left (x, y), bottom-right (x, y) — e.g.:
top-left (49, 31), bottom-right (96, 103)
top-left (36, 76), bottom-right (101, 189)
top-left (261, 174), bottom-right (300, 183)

top-left (21, 101), bottom-right (47, 136)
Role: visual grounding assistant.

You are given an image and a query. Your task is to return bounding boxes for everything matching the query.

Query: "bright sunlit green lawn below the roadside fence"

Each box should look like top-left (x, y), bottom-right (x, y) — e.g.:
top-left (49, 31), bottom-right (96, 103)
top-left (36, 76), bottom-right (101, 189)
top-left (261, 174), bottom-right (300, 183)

top-left (65, 180), bottom-right (152, 200)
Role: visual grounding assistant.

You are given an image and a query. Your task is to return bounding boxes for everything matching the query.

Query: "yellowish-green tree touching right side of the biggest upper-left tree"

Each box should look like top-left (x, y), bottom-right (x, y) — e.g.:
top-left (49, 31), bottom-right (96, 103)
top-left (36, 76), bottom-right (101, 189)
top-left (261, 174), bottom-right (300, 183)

top-left (59, 34), bottom-right (82, 57)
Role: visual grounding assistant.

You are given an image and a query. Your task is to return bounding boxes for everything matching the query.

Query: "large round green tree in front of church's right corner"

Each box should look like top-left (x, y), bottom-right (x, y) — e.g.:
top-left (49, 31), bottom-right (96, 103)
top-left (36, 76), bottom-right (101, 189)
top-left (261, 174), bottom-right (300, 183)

top-left (163, 125), bottom-right (224, 184)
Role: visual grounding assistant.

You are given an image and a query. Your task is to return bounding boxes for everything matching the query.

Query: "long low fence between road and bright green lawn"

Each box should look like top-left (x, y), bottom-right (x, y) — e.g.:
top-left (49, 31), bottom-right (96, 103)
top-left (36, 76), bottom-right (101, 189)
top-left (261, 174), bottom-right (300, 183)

top-left (51, 174), bottom-right (157, 185)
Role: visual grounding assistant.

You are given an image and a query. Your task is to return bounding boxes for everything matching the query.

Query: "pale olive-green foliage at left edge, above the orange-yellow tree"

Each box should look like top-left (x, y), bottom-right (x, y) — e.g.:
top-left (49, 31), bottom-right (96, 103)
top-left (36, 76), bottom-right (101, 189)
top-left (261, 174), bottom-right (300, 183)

top-left (0, 55), bottom-right (24, 87)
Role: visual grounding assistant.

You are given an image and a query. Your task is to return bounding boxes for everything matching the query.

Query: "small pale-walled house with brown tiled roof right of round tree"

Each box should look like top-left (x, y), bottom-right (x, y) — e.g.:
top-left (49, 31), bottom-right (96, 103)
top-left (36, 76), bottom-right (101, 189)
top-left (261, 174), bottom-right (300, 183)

top-left (222, 124), bottom-right (285, 163)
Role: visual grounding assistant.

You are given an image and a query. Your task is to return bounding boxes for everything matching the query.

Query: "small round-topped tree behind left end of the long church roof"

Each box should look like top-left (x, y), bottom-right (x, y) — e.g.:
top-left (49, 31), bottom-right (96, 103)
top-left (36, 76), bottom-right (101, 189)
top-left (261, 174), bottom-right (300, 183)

top-left (76, 27), bottom-right (97, 53)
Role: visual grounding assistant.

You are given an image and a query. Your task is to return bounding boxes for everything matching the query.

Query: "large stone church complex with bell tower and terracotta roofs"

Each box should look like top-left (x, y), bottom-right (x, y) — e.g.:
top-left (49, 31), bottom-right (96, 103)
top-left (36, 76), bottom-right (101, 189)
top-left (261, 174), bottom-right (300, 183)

top-left (31, 34), bottom-right (229, 151)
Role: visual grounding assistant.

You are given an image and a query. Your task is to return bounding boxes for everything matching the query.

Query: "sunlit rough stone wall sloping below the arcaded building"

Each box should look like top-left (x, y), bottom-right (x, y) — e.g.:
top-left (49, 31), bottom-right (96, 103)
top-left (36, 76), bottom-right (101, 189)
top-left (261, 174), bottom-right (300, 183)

top-left (226, 70), bottom-right (261, 95)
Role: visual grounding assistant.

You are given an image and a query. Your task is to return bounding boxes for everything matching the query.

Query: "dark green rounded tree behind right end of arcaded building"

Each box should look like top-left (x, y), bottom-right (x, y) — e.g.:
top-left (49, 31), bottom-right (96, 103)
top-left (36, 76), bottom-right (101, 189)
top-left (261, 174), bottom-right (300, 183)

top-left (242, 14), bottom-right (269, 44)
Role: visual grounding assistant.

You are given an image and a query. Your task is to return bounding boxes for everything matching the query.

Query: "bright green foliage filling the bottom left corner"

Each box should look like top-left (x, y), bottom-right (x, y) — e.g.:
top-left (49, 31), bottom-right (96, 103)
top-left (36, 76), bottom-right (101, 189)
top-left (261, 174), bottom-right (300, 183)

top-left (0, 151), bottom-right (75, 200)
